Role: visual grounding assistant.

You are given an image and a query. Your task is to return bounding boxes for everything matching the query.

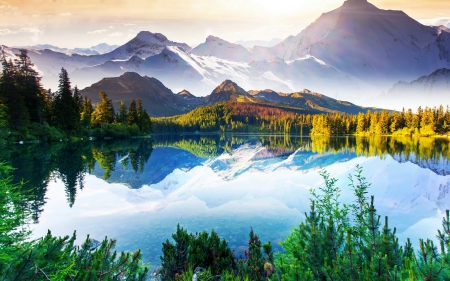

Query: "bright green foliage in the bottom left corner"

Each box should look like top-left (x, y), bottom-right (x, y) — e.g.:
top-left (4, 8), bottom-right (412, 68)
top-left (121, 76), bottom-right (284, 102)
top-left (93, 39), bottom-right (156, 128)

top-left (0, 163), bottom-right (148, 280)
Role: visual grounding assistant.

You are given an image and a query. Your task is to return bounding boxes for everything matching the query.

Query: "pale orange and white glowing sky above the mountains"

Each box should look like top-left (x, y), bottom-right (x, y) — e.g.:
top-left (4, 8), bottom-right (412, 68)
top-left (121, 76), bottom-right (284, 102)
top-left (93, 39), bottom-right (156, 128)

top-left (0, 0), bottom-right (450, 48)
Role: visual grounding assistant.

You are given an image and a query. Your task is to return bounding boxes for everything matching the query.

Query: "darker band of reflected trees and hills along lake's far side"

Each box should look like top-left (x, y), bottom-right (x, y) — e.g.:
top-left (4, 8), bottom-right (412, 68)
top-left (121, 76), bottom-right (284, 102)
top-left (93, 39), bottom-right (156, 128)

top-left (0, 135), bottom-right (450, 213)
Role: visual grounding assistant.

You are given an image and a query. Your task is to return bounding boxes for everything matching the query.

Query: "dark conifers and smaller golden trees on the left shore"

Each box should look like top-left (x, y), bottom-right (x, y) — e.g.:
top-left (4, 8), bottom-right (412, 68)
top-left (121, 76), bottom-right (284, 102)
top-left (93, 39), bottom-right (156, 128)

top-left (0, 49), bottom-right (151, 140)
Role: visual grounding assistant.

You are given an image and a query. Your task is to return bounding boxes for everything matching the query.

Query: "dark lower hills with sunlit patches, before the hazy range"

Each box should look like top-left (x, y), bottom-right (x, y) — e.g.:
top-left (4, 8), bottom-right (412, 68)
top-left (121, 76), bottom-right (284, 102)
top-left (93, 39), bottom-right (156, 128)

top-left (81, 72), bottom-right (377, 117)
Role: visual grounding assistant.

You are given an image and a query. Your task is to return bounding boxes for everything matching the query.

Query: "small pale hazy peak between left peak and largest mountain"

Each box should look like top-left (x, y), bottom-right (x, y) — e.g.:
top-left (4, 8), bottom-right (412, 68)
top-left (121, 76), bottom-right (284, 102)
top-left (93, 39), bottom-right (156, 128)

top-left (191, 36), bottom-right (253, 62)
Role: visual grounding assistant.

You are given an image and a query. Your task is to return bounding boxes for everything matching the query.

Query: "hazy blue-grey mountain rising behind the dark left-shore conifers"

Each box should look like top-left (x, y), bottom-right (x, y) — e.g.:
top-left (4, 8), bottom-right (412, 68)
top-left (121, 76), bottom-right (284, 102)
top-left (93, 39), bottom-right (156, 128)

top-left (0, 31), bottom-right (191, 89)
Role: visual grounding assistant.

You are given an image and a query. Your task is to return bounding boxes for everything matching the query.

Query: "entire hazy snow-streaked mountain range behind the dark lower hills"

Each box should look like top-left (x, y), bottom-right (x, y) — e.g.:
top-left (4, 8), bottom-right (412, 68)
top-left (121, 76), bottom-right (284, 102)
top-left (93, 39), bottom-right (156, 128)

top-left (2, 0), bottom-right (450, 109)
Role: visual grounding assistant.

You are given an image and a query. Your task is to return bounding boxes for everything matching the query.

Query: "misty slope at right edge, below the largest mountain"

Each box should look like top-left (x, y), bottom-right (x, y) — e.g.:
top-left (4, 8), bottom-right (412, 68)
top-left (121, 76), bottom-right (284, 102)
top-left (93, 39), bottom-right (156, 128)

top-left (382, 68), bottom-right (450, 109)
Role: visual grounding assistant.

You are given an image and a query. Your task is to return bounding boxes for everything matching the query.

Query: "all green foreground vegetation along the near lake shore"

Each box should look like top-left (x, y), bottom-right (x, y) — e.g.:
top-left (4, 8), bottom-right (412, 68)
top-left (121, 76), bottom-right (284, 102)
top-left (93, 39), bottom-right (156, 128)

top-left (4, 154), bottom-right (450, 280)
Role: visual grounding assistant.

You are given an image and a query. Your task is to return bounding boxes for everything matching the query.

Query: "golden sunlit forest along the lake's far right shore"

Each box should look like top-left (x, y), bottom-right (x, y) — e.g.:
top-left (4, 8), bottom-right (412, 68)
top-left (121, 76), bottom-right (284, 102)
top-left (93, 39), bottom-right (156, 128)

top-left (152, 102), bottom-right (450, 136)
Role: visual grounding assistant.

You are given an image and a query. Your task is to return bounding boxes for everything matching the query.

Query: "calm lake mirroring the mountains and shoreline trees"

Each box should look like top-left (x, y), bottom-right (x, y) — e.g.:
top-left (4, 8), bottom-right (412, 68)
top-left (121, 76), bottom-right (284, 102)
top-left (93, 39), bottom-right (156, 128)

top-left (0, 135), bottom-right (450, 267)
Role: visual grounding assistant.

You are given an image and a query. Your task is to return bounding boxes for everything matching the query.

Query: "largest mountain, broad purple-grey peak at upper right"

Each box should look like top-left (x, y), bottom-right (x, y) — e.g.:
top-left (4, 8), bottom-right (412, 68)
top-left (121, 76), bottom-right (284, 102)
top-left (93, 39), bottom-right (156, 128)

top-left (252, 0), bottom-right (450, 93)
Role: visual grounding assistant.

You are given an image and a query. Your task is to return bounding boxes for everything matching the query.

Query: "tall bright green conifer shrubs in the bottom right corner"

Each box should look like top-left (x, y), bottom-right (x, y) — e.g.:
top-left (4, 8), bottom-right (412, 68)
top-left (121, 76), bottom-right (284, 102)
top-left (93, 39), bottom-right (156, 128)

top-left (275, 166), bottom-right (450, 280)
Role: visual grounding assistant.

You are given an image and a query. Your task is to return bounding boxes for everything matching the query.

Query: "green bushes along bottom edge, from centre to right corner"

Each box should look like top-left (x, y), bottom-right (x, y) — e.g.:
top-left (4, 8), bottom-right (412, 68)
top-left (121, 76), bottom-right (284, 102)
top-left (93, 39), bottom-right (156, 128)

top-left (156, 167), bottom-right (450, 281)
